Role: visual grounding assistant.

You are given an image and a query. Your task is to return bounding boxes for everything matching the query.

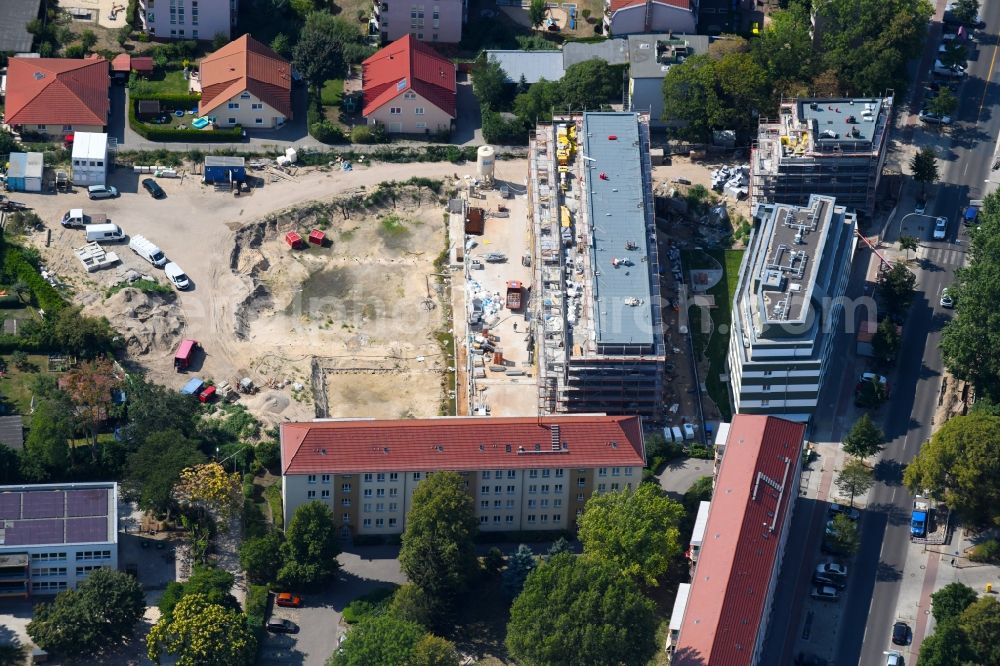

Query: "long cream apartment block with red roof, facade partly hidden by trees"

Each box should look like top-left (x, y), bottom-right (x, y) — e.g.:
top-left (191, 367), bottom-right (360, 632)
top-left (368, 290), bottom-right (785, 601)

top-left (281, 415), bottom-right (645, 534)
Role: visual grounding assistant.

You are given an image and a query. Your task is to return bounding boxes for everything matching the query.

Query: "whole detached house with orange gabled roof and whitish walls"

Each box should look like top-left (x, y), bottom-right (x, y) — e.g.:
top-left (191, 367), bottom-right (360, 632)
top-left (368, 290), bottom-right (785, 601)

top-left (198, 35), bottom-right (292, 129)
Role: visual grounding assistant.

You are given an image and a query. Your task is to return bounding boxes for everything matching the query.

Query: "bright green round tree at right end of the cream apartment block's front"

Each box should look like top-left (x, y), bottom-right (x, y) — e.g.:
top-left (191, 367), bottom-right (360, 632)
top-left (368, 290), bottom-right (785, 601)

top-left (578, 483), bottom-right (684, 585)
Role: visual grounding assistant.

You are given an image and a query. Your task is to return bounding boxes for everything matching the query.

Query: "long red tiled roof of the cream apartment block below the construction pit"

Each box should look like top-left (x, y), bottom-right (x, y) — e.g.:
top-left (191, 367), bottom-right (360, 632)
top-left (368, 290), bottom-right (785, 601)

top-left (281, 415), bottom-right (645, 474)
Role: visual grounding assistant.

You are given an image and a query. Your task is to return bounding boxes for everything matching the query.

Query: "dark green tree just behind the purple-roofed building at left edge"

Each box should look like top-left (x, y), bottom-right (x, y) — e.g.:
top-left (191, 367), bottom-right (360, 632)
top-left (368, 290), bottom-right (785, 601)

top-left (21, 399), bottom-right (73, 482)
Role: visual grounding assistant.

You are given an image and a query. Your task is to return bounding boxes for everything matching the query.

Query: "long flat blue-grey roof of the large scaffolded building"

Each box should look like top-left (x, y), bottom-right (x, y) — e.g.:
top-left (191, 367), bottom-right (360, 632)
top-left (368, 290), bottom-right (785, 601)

top-left (583, 113), bottom-right (659, 346)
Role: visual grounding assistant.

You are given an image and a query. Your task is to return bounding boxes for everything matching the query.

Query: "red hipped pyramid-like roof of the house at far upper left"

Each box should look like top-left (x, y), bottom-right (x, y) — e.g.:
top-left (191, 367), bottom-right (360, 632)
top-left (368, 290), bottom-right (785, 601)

top-left (6, 57), bottom-right (110, 126)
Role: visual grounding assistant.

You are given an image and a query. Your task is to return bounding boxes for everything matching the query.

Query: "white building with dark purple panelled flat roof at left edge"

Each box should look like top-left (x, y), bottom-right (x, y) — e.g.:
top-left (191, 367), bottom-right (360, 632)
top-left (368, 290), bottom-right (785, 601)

top-left (0, 482), bottom-right (118, 597)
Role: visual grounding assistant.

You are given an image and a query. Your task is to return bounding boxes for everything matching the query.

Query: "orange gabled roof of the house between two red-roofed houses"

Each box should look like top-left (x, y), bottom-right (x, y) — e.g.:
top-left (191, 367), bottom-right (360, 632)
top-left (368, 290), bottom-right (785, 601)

top-left (198, 35), bottom-right (292, 118)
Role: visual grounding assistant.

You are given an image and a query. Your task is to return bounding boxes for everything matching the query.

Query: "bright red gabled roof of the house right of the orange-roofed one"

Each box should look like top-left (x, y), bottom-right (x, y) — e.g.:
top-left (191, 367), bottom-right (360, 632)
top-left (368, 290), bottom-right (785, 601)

top-left (361, 35), bottom-right (455, 118)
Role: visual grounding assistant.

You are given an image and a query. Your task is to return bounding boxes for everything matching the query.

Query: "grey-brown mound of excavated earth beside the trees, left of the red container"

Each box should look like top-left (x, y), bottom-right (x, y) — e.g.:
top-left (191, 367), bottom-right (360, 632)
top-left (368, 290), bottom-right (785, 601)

top-left (102, 287), bottom-right (184, 356)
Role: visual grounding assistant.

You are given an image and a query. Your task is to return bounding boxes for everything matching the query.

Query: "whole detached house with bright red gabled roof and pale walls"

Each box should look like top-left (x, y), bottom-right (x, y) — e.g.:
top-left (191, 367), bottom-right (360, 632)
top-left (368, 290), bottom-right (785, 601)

top-left (361, 35), bottom-right (456, 134)
